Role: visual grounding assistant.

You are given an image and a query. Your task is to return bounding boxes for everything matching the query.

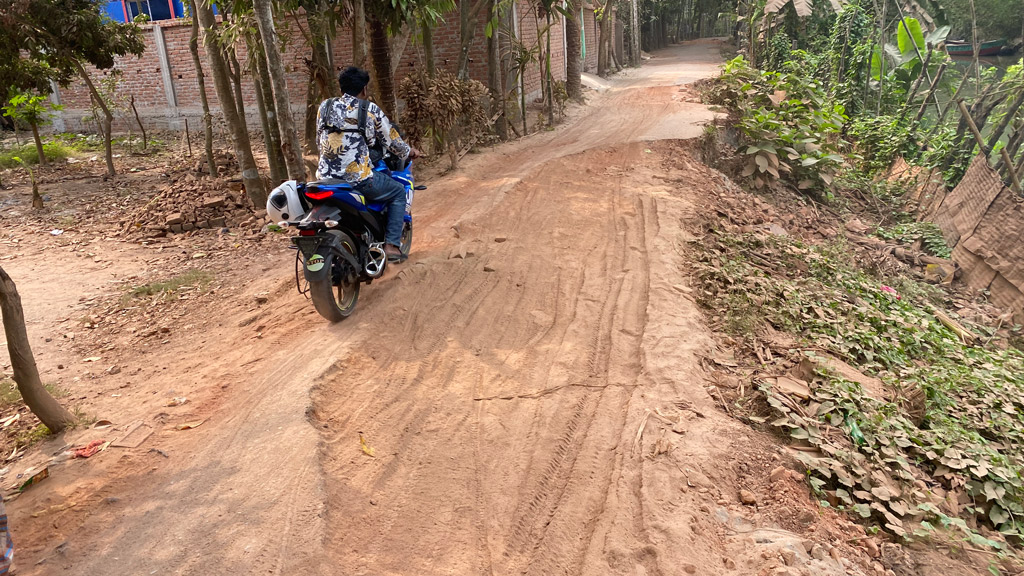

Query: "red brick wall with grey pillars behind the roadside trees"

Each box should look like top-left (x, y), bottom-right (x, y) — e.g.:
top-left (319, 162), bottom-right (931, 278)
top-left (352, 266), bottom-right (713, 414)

top-left (59, 2), bottom-right (552, 130)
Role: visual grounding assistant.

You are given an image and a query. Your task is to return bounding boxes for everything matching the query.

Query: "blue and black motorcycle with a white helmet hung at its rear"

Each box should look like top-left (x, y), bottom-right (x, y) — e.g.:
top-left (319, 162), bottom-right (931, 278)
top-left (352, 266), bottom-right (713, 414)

top-left (267, 157), bottom-right (427, 322)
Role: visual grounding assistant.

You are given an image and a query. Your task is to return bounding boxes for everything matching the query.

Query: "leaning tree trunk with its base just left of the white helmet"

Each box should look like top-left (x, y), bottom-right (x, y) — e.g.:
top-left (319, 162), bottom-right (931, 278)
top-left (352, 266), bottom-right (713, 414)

top-left (197, 0), bottom-right (266, 208)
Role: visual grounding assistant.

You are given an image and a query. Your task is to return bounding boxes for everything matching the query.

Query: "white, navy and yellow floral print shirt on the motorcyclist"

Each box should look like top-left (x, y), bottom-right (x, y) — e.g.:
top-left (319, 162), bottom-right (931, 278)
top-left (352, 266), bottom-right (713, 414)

top-left (316, 94), bottom-right (411, 184)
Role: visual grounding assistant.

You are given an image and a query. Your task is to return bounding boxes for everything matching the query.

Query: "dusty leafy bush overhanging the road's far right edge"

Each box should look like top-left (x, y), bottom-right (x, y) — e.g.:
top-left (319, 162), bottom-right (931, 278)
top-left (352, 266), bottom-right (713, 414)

top-left (720, 56), bottom-right (847, 195)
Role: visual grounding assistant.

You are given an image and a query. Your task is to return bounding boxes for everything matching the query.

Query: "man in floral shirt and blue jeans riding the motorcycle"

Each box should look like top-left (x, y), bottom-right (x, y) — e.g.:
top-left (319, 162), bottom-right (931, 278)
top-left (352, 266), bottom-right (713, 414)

top-left (316, 66), bottom-right (420, 261)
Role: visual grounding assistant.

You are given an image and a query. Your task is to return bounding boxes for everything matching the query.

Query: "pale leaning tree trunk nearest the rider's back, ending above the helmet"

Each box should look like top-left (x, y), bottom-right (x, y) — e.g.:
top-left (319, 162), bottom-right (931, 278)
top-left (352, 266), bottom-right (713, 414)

top-left (253, 0), bottom-right (306, 181)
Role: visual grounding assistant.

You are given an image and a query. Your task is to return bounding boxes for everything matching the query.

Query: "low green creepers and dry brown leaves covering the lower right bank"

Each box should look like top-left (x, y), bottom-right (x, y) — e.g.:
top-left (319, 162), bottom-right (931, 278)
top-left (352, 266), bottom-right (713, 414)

top-left (695, 228), bottom-right (1024, 549)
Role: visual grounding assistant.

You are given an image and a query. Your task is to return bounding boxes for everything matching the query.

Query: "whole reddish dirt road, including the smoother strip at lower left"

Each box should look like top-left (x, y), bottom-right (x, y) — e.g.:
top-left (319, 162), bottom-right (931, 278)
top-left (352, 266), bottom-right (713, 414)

top-left (12, 42), bottom-right (880, 575)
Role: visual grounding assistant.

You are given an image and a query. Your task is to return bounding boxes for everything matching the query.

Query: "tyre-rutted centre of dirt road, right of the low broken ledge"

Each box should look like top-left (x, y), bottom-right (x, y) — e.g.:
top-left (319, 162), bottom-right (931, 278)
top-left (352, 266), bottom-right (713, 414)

top-left (314, 44), bottom-right (770, 575)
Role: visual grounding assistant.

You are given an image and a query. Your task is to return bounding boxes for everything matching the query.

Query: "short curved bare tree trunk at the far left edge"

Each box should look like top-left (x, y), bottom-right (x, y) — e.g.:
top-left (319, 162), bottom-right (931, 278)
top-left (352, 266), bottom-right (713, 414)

top-left (0, 268), bottom-right (75, 434)
